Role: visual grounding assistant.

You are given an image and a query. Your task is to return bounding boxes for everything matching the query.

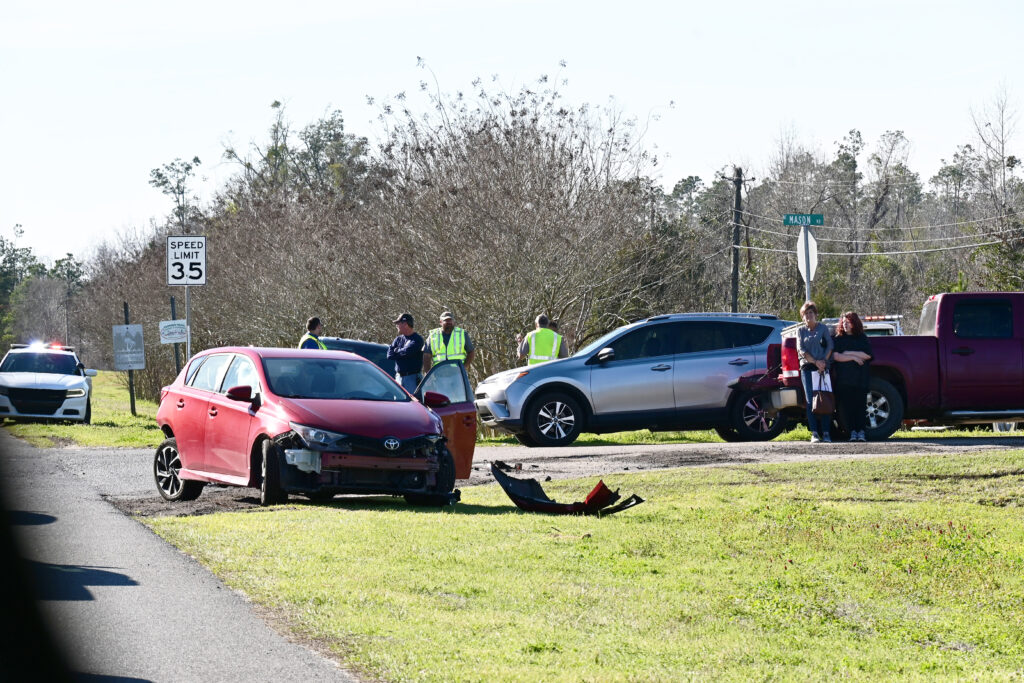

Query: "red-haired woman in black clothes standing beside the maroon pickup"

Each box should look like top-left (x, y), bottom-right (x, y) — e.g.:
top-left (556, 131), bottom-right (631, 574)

top-left (833, 310), bottom-right (874, 441)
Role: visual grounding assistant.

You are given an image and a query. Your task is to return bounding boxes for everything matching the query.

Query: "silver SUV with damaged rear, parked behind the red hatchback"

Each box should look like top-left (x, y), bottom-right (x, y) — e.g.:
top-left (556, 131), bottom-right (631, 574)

top-left (475, 313), bottom-right (792, 446)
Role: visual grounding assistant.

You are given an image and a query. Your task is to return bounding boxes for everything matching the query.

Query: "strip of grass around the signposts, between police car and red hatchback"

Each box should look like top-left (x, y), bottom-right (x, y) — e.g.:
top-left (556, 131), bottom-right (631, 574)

top-left (4, 372), bottom-right (164, 449)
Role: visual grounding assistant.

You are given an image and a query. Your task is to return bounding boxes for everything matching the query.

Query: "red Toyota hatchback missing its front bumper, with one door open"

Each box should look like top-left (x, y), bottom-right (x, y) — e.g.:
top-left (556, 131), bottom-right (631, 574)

top-left (153, 347), bottom-right (476, 505)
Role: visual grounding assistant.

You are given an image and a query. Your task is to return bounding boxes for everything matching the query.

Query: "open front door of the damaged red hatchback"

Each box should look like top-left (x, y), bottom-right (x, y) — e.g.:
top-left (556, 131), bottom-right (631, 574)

top-left (416, 360), bottom-right (476, 479)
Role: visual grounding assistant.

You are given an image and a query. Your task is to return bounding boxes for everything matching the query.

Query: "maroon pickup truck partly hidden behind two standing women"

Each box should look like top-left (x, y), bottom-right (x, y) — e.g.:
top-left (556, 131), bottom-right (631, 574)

top-left (752, 292), bottom-right (1024, 440)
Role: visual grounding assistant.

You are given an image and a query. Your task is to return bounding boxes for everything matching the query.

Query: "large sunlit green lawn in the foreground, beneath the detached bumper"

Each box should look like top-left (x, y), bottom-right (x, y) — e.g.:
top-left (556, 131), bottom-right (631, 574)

top-left (145, 452), bottom-right (1024, 681)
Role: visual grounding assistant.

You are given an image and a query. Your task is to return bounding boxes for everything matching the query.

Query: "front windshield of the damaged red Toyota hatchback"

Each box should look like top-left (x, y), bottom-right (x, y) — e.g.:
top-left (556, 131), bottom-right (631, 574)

top-left (263, 358), bottom-right (410, 401)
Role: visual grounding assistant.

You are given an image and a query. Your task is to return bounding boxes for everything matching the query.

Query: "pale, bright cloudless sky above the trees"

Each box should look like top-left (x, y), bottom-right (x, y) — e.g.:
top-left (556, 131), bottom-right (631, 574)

top-left (0, 0), bottom-right (1024, 262)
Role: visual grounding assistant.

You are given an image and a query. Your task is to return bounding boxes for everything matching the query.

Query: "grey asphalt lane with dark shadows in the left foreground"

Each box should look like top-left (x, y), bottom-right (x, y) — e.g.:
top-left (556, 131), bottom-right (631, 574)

top-left (0, 430), bottom-right (357, 682)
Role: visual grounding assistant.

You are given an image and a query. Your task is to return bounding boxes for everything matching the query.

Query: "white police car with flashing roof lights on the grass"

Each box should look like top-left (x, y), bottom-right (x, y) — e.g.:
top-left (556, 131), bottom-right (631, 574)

top-left (0, 343), bottom-right (96, 424)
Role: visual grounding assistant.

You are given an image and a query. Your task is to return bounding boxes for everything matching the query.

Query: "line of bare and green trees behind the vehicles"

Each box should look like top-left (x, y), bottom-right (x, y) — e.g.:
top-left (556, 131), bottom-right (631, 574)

top-left (6, 78), bottom-right (1024, 397)
